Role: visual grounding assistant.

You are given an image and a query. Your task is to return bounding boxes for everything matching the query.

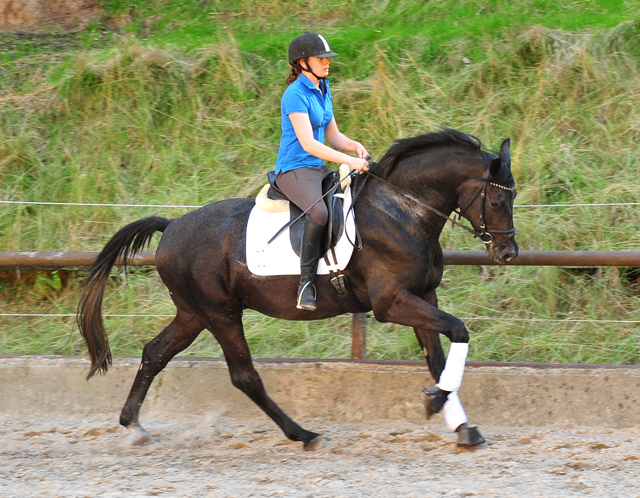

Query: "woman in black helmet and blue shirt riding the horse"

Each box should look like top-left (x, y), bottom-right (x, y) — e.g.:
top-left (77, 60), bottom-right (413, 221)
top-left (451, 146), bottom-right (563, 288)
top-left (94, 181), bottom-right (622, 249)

top-left (276, 31), bottom-right (369, 311)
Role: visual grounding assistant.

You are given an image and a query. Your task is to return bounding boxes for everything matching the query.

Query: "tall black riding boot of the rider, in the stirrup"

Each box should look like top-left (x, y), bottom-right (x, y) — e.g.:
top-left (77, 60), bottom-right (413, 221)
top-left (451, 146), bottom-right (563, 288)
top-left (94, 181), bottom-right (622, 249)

top-left (296, 215), bottom-right (327, 311)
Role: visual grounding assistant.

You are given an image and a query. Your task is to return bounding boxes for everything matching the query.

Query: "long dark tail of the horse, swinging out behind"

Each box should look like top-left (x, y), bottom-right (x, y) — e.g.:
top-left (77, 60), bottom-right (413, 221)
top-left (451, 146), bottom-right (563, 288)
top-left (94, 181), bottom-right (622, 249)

top-left (76, 216), bottom-right (171, 380)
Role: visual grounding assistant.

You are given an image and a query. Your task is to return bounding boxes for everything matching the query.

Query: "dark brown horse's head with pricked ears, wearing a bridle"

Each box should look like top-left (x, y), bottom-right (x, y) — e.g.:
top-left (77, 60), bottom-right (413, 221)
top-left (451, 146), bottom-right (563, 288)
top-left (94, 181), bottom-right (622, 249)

top-left (458, 138), bottom-right (518, 263)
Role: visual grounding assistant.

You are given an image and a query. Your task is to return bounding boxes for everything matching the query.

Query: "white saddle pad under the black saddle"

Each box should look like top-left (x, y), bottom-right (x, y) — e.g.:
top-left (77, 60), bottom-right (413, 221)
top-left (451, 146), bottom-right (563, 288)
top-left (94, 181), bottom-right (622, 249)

top-left (247, 188), bottom-right (356, 277)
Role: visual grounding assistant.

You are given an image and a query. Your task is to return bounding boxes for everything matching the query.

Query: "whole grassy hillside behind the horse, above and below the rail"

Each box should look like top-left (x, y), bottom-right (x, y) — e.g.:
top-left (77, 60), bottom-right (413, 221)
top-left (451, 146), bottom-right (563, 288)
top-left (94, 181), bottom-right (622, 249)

top-left (0, 0), bottom-right (640, 364)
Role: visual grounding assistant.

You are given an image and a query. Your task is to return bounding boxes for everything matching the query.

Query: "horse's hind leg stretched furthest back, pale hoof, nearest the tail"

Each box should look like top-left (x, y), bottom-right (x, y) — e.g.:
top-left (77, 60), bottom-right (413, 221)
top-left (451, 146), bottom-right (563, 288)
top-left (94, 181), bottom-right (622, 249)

top-left (120, 311), bottom-right (204, 445)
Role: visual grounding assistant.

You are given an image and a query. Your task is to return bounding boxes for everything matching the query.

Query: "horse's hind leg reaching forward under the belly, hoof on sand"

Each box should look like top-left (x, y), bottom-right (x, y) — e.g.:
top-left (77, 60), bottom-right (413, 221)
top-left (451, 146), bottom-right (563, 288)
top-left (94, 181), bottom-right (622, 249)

top-left (211, 316), bottom-right (325, 451)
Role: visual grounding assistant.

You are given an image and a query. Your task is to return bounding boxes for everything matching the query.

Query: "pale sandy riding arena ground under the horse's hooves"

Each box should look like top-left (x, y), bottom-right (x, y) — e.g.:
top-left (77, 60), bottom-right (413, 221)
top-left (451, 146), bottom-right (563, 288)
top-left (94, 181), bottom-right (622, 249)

top-left (0, 417), bottom-right (640, 498)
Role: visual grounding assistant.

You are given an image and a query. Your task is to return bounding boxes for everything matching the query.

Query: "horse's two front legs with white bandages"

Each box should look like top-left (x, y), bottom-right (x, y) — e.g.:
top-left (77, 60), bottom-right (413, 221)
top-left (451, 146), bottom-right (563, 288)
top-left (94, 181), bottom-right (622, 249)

top-left (374, 292), bottom-right (485, 446)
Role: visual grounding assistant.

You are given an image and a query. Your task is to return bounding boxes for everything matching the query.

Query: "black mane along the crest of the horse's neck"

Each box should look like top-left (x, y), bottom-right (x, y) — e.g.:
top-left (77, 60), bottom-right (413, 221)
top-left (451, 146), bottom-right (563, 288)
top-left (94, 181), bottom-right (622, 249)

top-left (373, 128), bottom-right (482, 178)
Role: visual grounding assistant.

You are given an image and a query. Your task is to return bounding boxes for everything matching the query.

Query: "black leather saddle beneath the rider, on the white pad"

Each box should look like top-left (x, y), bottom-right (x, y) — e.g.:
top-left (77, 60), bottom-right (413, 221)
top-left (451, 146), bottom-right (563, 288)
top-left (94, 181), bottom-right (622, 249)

top-left (266, 171), bottom-right (346, 256)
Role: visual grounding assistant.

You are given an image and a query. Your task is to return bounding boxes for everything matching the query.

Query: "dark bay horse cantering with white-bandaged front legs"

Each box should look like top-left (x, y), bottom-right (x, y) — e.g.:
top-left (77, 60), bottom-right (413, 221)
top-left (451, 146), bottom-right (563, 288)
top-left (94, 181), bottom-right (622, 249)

top-left (78, 129), bottom-right (518, 450)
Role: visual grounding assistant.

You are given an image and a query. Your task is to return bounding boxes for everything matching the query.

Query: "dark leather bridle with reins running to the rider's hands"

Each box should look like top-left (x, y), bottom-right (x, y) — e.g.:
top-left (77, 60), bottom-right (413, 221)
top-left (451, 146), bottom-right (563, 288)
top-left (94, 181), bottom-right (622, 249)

top-left (358, 168), bottom-right (516, 250)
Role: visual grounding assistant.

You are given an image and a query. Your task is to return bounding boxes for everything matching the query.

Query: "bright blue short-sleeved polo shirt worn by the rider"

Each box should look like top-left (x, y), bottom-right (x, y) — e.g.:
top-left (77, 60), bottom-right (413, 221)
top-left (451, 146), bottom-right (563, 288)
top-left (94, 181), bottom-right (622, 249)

top-left (276, 74), bottom-right (333, 173)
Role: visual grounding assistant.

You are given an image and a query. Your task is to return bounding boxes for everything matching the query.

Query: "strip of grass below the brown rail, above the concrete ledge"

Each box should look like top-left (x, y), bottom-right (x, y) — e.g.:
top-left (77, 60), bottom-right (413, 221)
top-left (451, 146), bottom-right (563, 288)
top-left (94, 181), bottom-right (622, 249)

top-left (0, 267), bottom-right (640, 364)
